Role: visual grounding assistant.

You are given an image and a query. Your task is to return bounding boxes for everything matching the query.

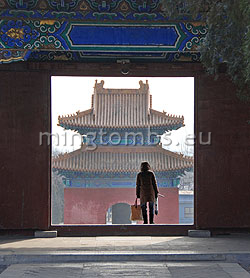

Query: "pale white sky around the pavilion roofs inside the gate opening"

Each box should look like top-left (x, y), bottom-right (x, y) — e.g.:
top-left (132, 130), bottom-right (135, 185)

top-left (51, 76), bottom-right (194, 153)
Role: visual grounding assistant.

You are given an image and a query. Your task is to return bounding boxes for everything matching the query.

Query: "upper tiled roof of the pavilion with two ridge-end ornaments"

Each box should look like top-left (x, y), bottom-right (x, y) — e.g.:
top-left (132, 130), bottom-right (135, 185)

top-left (58, 81), bottom-right (184, 130)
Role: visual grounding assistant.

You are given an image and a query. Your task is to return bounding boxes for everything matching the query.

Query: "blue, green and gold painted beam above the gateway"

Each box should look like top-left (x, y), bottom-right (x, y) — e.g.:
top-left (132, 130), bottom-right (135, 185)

top-left (0, 0), bottom-right (207, 63)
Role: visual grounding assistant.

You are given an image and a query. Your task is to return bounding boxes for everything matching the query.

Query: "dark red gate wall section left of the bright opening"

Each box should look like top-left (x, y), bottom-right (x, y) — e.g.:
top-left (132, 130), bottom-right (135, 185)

top-left (0, 66), bottom-right (50, 229)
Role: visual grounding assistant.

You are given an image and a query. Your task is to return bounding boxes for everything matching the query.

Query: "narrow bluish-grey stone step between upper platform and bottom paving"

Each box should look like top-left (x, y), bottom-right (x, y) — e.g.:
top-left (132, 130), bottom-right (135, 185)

top-left (0, 252), bottom-right (250, 265)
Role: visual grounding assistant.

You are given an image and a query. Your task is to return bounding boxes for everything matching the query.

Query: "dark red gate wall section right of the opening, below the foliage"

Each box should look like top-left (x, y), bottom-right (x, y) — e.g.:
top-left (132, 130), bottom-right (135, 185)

top-left (196, 74), bottom-right (250, 228)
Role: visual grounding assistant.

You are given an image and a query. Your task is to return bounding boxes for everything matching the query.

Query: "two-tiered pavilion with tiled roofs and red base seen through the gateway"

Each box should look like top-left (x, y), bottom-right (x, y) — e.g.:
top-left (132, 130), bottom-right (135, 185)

top-left (52, 81), bottom-right (193, 224)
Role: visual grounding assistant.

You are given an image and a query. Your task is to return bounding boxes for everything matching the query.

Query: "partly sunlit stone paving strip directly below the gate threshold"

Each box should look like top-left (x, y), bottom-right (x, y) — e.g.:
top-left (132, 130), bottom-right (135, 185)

top-left (0, 234), bottom-right (250, 255)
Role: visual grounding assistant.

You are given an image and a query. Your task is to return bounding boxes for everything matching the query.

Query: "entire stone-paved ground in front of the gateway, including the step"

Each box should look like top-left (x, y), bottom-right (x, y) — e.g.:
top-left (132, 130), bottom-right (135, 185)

top-left (0, 234), bottom-right (250, 278)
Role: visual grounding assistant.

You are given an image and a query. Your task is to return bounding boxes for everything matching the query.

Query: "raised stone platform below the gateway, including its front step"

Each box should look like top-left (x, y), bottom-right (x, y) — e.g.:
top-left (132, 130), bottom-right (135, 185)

top-left (0, 234), bottom-right (250, 272)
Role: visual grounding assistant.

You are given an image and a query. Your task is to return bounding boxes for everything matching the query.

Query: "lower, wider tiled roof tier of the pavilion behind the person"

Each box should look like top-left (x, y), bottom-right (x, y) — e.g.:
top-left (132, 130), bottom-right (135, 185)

top-left (52, 145), bottom-right (193, 172)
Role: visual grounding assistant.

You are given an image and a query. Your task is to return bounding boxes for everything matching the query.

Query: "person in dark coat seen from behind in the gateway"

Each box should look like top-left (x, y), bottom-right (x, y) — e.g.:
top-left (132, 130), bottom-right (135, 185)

top-left (136, 162), bottom-right (159, 224)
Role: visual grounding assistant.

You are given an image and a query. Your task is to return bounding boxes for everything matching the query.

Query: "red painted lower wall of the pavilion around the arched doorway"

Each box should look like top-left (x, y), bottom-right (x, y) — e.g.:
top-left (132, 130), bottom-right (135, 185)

top-left (64, 188), bottom-right (179, 224)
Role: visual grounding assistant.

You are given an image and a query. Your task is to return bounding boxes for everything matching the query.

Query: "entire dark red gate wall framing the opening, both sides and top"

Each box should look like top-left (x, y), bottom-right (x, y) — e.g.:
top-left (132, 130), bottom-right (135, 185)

top-left (0, 63), bottom-right (250, 231)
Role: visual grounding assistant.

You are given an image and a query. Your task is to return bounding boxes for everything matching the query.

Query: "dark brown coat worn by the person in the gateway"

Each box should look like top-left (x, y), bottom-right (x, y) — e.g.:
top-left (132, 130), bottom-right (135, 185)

top-left (136, 171), bottom-right (159, 204)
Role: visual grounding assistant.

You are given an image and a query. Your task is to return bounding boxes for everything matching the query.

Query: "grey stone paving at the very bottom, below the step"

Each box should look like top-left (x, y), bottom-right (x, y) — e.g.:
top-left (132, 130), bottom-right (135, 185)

top-left (0, 262), bottom-right (250, 278)
